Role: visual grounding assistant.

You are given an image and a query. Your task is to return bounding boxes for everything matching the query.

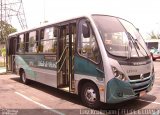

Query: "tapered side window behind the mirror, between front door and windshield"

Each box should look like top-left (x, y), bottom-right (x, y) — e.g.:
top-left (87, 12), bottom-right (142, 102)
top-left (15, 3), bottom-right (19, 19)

top-left (78, 19), bottom-right (101, 63)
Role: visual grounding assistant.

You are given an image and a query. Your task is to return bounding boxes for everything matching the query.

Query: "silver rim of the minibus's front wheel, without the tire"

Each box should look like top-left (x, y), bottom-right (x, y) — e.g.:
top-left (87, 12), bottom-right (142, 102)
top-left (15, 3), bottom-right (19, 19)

top-left (85, 88), bottom-right (97, 103)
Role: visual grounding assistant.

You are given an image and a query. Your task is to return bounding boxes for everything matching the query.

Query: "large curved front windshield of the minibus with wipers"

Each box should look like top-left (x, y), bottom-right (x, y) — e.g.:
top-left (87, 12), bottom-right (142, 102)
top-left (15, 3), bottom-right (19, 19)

top-left (93, 15), bottom-right (148, 58)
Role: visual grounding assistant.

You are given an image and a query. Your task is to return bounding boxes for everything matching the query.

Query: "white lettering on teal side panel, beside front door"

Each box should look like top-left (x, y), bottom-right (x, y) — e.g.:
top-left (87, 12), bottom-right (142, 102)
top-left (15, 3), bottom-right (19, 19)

top-left (38, 60), bottom-right (57, 68)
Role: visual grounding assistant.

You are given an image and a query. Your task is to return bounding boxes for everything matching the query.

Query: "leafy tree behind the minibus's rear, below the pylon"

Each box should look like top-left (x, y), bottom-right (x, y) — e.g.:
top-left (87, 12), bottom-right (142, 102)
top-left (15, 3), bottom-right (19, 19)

top-left (0, 21), bottom-right (17, 43)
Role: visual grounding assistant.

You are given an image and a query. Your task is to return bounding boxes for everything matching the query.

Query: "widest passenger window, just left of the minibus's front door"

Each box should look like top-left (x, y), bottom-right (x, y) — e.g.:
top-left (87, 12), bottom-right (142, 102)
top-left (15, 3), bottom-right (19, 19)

top-left (40, 27), bottom-right (57, 54)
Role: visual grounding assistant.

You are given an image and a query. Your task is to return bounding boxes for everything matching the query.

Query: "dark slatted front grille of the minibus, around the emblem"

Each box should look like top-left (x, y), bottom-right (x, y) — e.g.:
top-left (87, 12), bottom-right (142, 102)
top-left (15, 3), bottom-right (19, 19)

top-left (130, 73), bottom-right (151, 95)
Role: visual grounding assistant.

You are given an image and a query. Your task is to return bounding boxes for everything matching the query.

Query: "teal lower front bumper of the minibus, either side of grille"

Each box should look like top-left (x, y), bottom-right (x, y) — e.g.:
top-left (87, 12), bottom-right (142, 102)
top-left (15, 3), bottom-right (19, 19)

top-left (106, 75), bottom-right (154, 103)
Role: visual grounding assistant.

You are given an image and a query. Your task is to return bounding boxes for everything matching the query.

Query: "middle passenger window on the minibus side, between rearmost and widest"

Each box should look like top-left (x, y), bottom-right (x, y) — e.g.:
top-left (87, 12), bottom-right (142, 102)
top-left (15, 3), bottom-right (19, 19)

top-left (29, 31), bottom-right (38, 53)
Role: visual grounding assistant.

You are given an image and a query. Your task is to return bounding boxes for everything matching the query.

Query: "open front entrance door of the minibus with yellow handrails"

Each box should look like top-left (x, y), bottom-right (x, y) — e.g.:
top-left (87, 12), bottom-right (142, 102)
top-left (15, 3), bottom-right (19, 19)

top-left (57, 24), bottom-right (76, 92)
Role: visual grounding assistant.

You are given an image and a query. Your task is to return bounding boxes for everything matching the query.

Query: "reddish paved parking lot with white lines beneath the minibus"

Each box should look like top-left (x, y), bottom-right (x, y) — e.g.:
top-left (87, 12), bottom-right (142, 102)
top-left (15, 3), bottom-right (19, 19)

top-left (0, 61), bottom-right (160, 115)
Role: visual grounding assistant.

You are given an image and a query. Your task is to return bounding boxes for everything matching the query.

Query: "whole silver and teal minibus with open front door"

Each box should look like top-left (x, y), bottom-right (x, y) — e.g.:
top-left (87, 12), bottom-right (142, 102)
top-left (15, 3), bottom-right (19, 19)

top-left (6, 14), bottom-right (154, 108)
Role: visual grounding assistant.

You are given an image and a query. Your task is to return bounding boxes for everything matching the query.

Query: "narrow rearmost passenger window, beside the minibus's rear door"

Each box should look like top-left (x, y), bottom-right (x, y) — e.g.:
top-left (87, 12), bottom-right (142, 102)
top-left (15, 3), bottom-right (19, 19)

top-left (17, 34), bottom-right (24, 53)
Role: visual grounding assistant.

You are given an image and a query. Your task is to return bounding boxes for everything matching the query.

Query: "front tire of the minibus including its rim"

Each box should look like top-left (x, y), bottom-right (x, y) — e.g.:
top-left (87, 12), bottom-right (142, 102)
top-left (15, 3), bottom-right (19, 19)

top-left (81, 82), bottom-right (100, 109)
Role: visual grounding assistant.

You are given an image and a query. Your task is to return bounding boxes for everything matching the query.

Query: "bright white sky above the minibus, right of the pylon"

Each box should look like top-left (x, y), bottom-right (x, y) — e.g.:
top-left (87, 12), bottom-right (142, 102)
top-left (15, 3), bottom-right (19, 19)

top-left (13, 0), bottom-right (160, 37)
